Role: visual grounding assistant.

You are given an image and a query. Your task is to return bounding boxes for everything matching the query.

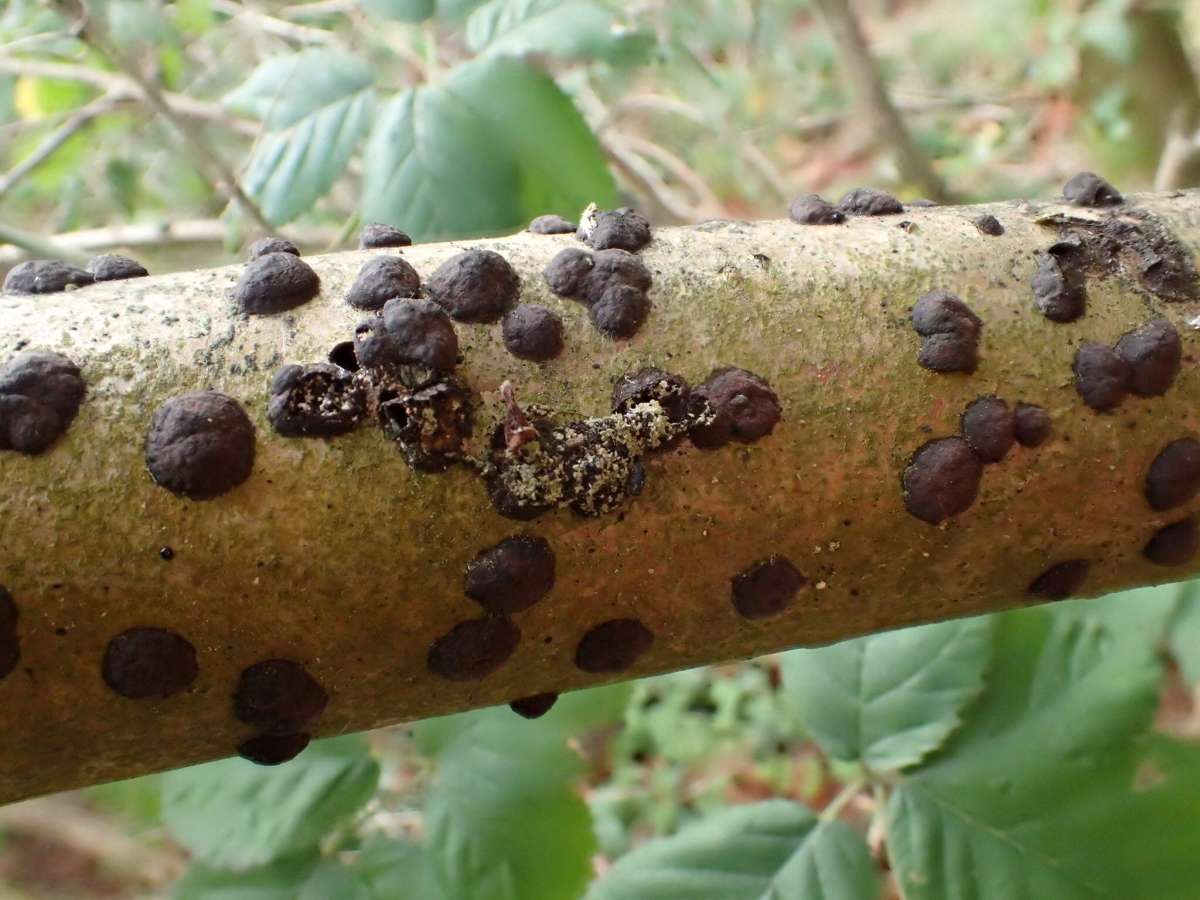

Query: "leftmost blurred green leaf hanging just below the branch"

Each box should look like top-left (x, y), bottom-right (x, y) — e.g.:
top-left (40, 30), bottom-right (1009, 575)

top-left (163, 737), bottom-right (379, 869)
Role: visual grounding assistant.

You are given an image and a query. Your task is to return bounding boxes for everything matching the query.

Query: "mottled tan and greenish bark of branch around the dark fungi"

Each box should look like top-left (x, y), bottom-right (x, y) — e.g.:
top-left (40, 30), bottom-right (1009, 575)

top-left (0, 192), bottom-right (1200, 800)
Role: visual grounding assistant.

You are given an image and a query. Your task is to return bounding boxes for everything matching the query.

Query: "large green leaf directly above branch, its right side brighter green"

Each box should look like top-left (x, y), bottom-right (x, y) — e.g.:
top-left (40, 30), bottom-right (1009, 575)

top-left (362, 56), bottom-right (616, 240)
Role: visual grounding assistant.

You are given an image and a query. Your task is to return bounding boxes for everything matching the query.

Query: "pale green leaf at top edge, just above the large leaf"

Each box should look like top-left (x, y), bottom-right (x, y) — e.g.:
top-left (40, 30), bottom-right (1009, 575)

top-left (467, 0), bottom-right (654, 62)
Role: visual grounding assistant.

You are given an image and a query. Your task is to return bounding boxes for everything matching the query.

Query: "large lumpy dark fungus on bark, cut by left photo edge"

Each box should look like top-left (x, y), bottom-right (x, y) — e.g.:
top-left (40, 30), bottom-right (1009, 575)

top-left (0, 350), bottom-right (88, 455)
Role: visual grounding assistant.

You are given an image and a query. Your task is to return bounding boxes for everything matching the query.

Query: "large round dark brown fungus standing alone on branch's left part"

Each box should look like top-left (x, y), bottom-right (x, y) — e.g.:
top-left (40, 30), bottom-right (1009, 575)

top-left (145, 391), bottom-right (254, 500)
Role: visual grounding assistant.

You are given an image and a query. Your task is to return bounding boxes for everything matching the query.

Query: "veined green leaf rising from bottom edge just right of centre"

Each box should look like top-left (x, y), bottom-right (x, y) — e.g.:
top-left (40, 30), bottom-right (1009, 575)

top-left (587, 800), bottom-right (880, 900)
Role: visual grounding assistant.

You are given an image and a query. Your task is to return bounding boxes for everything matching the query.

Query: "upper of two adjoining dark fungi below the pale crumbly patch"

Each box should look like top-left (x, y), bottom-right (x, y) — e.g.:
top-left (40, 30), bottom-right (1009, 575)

top-left (463, 534), bottom-right (554, 614)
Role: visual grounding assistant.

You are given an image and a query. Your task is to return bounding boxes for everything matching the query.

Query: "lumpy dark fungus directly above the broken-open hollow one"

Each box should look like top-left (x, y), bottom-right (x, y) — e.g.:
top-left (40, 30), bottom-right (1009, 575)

top-left (354, 300), bottom-right (458, 388)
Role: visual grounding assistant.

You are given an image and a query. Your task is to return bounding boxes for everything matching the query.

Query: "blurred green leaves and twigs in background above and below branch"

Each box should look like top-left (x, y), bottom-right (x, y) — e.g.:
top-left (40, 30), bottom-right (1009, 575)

top-left (0, 0), bottom-right (1200, 900)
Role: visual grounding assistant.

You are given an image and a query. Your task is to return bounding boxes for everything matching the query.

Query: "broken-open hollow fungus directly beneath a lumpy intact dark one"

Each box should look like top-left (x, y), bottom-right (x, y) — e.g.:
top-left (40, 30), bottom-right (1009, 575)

top-left (379, 378), bottom-right (474, 472)
